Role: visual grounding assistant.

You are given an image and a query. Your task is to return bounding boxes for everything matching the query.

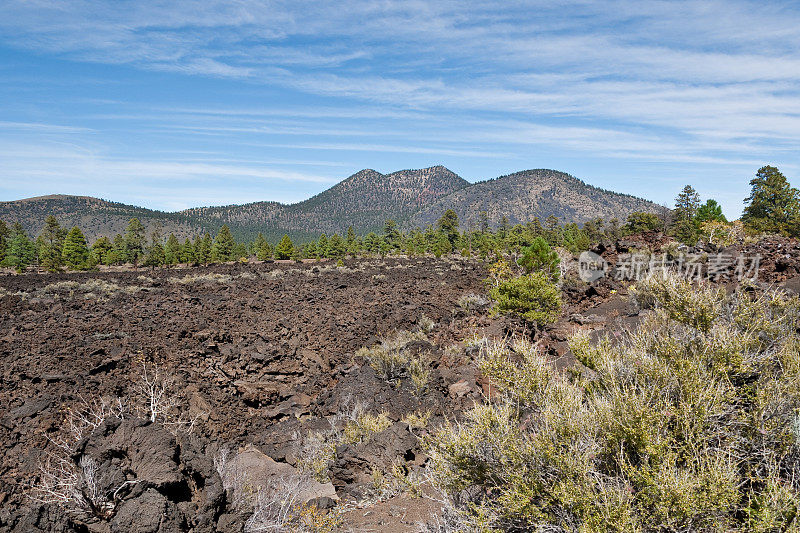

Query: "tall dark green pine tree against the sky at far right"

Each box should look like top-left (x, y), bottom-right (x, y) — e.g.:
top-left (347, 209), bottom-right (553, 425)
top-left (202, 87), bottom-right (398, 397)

top-left (742, 166), bottom-right (800, 233)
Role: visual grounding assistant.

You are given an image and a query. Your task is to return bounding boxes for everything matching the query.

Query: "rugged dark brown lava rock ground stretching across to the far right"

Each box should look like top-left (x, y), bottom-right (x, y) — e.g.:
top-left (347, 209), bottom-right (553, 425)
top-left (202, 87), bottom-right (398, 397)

top-left (0, 235), bottom-right (800, 533)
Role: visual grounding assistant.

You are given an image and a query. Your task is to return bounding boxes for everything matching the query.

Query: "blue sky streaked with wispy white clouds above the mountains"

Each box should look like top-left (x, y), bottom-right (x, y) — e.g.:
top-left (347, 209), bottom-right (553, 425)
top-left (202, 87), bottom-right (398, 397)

top-left (0, 0), bottom-right (800, 216)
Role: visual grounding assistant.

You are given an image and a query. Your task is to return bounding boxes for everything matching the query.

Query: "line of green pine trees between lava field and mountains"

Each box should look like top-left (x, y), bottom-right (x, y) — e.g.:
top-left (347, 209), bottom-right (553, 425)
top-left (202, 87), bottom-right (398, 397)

top-left (0, 166), bottom-right (800, 272)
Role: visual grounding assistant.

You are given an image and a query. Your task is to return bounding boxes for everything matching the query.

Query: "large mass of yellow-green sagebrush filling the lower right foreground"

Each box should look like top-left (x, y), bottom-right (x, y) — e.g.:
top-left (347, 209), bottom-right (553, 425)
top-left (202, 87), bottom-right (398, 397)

top-left (424, 279), bottom-right (800, 532)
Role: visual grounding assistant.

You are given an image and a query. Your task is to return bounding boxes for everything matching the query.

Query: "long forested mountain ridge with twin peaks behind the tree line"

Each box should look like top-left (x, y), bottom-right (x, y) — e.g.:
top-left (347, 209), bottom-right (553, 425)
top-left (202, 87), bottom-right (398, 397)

top-left (0, 165), bottom-right (664, 240)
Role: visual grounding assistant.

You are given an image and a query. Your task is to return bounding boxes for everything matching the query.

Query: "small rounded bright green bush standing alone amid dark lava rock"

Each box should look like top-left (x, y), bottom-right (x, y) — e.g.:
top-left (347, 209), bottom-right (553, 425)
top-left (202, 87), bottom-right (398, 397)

top-left (489, 272), bottom-right (561, 326)
